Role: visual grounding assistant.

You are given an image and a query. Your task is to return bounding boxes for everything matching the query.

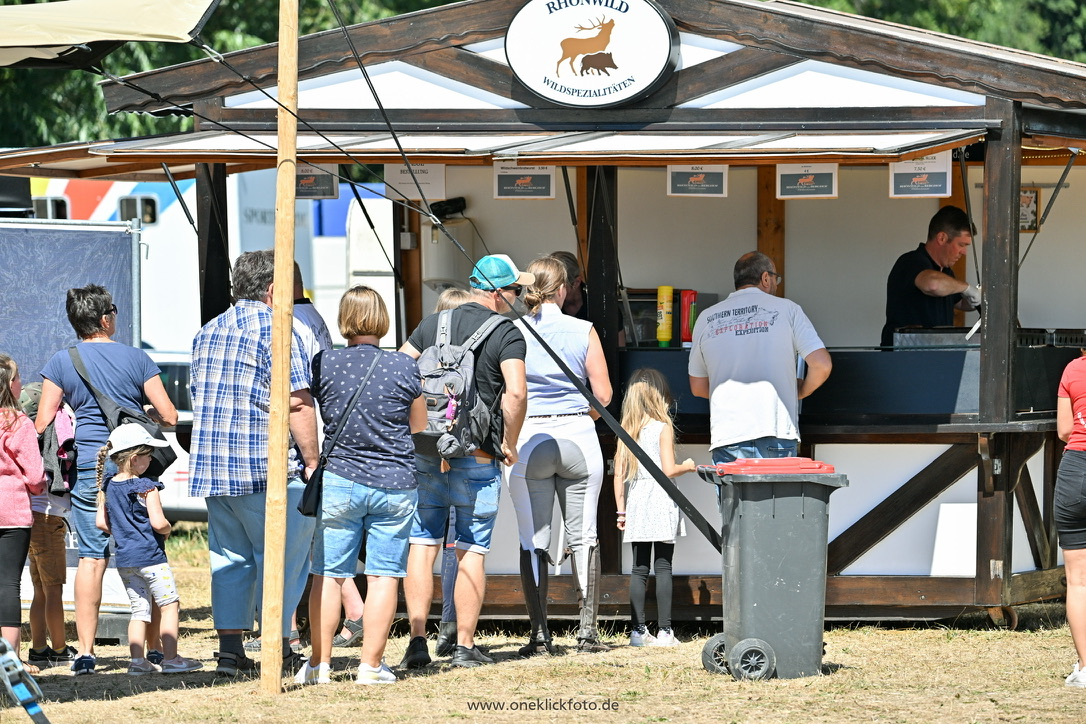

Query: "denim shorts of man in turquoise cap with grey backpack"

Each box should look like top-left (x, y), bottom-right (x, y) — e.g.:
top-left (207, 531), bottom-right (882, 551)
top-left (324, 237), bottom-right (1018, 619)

top-left (411, 455), bottom-right (502, 554)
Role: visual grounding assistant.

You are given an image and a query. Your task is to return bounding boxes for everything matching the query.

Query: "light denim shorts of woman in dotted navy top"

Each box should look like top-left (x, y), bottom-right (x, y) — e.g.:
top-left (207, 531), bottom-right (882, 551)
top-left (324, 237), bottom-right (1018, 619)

top-left (311, 470), bottom-right (418, 579)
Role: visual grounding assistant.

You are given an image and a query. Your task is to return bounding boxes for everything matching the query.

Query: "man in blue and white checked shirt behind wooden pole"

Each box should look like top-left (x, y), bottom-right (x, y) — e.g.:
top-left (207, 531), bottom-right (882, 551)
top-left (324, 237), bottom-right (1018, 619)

top-left (189, 250), bottom-right (318, 676)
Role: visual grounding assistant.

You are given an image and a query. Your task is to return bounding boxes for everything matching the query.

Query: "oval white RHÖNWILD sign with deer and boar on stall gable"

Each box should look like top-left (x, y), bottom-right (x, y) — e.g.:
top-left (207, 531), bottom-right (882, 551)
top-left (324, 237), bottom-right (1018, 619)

top-left (505, 0), bottom-right (679, 107)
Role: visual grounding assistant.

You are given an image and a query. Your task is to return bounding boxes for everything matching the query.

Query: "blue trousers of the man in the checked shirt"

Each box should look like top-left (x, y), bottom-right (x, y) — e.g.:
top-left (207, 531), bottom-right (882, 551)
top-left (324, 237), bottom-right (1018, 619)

top-left (205, 477), bottom-right (316, 636)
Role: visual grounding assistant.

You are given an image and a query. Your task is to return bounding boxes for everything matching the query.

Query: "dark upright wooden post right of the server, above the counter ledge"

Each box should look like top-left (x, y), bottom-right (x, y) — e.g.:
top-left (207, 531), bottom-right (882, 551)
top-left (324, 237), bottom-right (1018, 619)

top-left (980, 99), bottom-right (1022, 423)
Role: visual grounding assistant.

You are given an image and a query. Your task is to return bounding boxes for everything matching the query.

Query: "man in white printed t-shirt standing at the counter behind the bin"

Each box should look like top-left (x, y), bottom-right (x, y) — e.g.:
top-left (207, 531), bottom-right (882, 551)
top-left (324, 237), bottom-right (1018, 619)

top-left (689, 252), bottom-right (832, 462)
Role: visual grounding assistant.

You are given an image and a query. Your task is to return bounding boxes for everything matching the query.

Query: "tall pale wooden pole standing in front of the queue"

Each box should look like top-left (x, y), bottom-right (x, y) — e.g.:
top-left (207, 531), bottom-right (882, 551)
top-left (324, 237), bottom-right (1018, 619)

top-left (261, 0), bottom-right (298, 694)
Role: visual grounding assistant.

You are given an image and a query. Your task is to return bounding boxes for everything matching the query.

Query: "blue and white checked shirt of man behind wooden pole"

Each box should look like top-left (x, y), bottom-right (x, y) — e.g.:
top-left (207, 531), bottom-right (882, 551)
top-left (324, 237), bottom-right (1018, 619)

top-left (189, 300), bottom-right (312, 497)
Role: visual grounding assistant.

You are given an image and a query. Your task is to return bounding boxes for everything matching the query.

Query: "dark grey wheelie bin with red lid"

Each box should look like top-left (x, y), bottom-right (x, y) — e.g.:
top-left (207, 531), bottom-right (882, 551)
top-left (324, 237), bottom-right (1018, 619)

top-left (698, 458), bottom-right (848, 679)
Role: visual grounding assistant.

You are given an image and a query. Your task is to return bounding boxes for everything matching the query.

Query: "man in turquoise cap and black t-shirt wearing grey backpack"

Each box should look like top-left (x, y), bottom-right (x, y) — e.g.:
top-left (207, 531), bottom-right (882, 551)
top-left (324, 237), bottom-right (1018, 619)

top-left (400, 254), bottom-right (535, 669)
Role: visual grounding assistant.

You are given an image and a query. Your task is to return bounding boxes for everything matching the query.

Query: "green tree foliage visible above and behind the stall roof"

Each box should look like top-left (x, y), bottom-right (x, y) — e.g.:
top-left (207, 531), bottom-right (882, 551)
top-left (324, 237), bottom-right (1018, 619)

top-left (6, 0), bottom-right (1086, 147)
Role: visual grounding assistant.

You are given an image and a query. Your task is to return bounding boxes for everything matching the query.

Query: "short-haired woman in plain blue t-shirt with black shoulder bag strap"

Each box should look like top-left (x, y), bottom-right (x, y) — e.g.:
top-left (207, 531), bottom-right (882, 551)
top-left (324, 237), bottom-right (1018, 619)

top-left (35, 284), bottom-right (177, 675)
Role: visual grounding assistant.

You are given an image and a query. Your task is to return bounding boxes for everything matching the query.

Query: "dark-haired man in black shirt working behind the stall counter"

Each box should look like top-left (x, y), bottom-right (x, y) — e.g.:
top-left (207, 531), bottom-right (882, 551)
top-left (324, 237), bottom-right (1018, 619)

top-left (880, 206), bottom-right (981, 347)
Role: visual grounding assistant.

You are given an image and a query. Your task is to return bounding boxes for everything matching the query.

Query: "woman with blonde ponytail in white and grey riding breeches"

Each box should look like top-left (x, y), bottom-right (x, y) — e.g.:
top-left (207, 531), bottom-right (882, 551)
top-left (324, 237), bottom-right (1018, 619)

top-left (505, 257), bottom-right (611, 656)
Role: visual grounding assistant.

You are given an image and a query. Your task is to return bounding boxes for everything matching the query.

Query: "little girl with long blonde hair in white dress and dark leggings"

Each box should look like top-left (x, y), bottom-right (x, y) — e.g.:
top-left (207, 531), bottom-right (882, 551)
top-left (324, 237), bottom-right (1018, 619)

top-left (615, 368), bottom-right (696, 646)
